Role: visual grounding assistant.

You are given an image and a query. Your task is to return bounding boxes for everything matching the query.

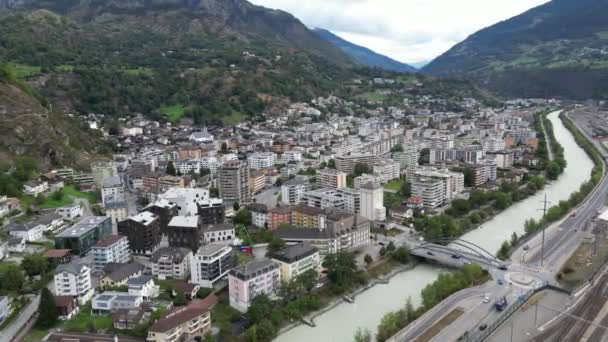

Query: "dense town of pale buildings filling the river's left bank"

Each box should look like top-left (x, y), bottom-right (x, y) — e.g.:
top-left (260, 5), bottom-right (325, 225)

top-left (0, 78), bottom-right (563, 342)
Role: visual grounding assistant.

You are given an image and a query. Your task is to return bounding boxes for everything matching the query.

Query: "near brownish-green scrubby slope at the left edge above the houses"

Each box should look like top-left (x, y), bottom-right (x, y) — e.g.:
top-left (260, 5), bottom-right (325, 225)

top-left (0, 66), bottom-right (109, 168)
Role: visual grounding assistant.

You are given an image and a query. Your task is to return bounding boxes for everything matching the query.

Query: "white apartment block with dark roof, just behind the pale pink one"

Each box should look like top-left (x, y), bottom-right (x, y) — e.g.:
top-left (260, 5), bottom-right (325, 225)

top-left (269, 243), bottom-right (321, 282)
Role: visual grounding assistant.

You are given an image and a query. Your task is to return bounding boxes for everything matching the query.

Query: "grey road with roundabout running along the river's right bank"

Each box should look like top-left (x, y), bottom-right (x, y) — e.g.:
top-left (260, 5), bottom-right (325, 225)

top-left (394, 110), bottom-right (608, 341)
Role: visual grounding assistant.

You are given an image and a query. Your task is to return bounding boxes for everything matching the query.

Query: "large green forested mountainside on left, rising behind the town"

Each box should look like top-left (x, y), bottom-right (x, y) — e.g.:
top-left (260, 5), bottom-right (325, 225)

top-left (0, 0), bottom-right (355, 124)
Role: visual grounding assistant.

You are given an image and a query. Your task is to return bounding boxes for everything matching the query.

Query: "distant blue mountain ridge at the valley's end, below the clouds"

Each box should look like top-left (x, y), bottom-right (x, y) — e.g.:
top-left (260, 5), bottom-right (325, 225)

top-left (314, 28), bottom-right (417, 72)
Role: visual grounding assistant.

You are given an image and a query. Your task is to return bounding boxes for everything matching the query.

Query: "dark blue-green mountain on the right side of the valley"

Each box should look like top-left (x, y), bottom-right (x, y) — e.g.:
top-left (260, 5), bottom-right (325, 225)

top-left (423, 0), bottom-right (608, 99)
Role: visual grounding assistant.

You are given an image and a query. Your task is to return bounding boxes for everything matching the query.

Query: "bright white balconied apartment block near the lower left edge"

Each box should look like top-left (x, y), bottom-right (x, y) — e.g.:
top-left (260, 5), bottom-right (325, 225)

top-left (54, 263), bottom-right (94, 304)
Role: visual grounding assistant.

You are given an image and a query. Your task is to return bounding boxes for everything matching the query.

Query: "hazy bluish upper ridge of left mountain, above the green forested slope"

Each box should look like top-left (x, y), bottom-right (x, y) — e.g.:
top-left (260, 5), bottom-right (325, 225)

top-left (0, 0), bottom-right (351, 65)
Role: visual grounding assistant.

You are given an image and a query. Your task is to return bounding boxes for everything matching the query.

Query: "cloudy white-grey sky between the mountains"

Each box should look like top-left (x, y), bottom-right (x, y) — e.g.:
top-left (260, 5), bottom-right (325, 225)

top-left (249, 0), bottom-right (548, 64)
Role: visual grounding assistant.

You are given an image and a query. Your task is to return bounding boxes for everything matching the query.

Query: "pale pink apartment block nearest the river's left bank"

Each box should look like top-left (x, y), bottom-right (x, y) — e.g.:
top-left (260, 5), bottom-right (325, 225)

top-left (228, 259), bottom-right (281, 312)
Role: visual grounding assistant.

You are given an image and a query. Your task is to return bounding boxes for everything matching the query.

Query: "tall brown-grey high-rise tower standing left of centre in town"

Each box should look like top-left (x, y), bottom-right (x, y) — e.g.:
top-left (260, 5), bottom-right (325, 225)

top-left (218, 161), bottom-right (251, 204)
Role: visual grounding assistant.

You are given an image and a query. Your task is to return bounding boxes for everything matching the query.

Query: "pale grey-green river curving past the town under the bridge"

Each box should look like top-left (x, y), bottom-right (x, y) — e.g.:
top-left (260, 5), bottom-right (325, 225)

top-left (275, 112), bottom-right (593, 342)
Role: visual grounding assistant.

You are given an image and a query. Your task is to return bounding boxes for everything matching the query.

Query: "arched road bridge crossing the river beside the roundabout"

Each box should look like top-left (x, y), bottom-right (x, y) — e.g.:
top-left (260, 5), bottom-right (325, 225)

top-left (408, 239), bottom-right (507, 270)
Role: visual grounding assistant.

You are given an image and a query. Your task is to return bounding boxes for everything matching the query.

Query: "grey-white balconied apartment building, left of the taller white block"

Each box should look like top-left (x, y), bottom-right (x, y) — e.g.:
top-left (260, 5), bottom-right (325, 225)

top-left (150, 247), bottom-right (192, 279)
